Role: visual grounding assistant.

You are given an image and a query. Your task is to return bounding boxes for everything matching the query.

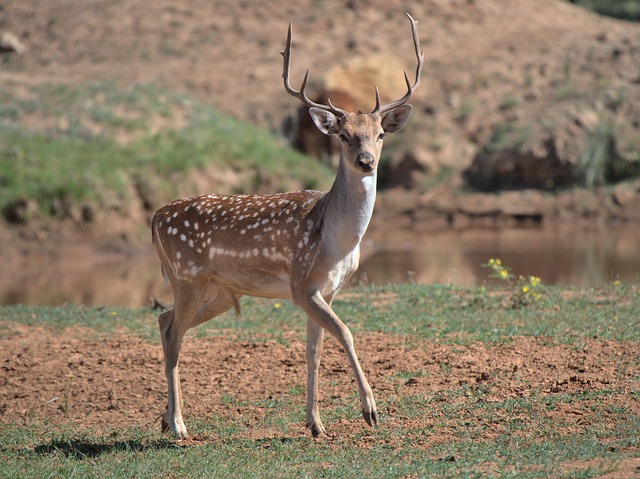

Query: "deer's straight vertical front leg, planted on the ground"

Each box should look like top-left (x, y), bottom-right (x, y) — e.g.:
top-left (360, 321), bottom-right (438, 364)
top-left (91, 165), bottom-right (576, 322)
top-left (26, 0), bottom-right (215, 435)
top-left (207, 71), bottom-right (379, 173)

top-left (307, 318), bottom-right (327, 437)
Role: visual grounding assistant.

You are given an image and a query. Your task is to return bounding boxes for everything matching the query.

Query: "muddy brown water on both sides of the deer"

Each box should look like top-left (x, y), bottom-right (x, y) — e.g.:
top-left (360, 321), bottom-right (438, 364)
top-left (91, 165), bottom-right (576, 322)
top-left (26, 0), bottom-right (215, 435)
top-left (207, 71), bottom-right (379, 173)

top-left (0, 227), bottom-right (640, 307)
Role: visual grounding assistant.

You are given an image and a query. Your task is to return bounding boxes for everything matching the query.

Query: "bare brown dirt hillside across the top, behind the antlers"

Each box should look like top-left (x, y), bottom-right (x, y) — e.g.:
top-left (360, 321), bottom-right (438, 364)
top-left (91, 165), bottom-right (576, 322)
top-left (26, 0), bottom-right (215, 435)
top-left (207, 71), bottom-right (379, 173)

top-left (0, 0), bottom-right (640, 238)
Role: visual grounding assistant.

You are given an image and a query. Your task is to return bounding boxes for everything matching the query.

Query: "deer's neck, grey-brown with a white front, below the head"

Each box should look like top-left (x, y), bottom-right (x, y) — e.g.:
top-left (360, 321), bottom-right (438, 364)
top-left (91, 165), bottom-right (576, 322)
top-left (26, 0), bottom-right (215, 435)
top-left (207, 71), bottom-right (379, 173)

top-left (322, 158), bottom-right (377, 254)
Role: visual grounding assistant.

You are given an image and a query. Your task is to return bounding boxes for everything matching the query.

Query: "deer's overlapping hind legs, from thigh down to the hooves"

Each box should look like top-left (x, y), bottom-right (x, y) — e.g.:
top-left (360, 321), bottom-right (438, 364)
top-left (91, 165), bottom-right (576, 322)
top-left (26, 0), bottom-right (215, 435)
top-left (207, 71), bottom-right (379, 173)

top-left (158, 283), bottom-right (203, 439)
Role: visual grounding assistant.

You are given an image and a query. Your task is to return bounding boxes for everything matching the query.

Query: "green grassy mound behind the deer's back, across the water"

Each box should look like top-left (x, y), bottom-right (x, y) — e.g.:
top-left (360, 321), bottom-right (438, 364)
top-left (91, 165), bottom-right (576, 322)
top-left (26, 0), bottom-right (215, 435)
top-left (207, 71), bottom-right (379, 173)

top-left (0, 83), bottom-right (332, 216)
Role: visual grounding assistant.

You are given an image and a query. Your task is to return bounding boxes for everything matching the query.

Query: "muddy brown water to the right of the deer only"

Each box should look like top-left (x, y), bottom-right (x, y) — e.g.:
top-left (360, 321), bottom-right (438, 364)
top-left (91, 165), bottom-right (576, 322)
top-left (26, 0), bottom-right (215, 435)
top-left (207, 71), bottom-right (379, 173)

top-left (355, 227), bottom-right (640, 286)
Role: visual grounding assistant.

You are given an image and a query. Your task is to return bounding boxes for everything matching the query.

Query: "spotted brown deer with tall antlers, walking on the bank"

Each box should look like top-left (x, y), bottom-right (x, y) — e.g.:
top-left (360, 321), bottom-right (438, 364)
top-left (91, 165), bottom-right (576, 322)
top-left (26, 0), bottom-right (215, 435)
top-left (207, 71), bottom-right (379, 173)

top-left (151, 14), bottom-right (424, 440)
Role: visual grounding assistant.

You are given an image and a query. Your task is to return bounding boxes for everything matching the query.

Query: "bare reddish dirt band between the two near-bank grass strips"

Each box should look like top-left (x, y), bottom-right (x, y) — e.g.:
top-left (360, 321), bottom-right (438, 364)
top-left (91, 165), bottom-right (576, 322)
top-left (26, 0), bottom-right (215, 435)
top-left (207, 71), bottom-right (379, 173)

top-left (0, 326), bottom-right (640, 448)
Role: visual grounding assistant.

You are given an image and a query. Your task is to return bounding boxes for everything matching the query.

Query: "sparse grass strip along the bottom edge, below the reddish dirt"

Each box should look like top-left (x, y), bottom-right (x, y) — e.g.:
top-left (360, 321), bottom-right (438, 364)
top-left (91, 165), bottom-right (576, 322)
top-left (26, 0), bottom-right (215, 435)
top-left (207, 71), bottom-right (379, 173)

top-left (3, 414), bottom-right (638, 478)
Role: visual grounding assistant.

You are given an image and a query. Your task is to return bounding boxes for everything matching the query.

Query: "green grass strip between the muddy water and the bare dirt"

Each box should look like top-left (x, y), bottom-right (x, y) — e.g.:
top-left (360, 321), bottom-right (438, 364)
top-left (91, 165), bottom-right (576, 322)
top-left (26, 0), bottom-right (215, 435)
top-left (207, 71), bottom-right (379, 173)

top-left (0, 284), bottom-right (640, 344)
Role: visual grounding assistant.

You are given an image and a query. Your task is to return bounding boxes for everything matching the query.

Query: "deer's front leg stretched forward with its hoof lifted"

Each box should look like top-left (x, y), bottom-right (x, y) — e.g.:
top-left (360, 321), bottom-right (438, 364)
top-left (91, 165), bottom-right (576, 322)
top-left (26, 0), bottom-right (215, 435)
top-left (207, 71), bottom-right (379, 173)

top-left (294, 291), bottom-right (378, 427)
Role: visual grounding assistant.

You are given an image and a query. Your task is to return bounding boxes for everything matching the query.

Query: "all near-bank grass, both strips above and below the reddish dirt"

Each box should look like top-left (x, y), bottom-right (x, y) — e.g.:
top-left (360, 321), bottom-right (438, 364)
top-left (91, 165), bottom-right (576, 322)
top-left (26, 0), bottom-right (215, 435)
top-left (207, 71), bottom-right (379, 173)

top-left (0, 285), bottom-right (640, 478)
